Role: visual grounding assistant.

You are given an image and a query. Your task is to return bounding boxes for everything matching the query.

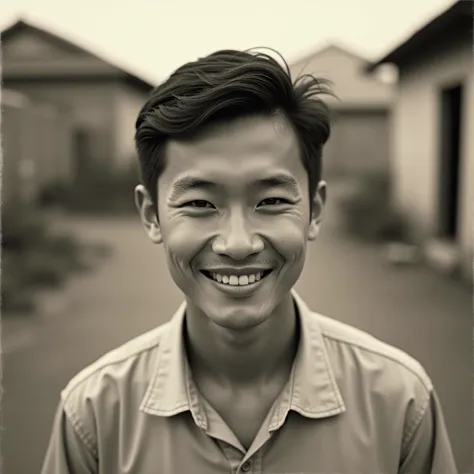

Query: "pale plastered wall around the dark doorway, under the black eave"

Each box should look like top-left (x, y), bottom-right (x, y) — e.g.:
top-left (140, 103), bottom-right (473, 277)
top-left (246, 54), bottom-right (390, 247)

top-left (391, 36), bottom-right (474, 275)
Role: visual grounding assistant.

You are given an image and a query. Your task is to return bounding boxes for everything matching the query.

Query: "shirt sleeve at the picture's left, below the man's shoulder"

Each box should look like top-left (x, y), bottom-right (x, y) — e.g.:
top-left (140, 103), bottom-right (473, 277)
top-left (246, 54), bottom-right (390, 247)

top-left (41, 403), bottom-right (99, 474)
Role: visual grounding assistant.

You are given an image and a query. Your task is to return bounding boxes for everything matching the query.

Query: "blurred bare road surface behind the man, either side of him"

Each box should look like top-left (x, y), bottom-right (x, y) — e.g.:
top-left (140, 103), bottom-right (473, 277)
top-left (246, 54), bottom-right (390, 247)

top-left (2, 201), bottom-right (473, 474)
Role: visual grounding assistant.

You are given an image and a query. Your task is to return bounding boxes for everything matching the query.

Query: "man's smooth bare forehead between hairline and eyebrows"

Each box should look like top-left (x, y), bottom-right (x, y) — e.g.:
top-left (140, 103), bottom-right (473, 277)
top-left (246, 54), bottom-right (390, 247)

top-left (160, 117), bottom-right (306, 187)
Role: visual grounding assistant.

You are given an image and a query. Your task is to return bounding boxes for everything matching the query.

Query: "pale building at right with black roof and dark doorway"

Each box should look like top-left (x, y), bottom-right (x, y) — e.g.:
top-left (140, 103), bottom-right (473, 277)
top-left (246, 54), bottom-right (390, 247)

top-left (368, 1), bottom-right (474, 278)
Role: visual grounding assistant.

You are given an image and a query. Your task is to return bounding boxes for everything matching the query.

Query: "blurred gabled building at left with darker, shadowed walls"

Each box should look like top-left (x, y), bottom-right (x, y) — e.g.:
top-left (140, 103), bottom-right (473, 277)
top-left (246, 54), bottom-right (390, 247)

top-left (1, 21), bottom-right (153, 203)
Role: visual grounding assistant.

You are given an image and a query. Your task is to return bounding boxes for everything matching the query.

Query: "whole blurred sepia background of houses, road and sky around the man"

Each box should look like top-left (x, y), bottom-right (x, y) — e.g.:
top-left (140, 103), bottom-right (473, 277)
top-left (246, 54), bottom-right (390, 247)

top-left (0, 0), bottom-right (474, 474)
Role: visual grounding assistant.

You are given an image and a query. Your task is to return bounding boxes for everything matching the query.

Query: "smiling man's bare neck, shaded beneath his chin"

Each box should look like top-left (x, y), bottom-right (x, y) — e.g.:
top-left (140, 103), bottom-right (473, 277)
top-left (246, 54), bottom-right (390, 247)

top-left (186, 294), bottom-right (299, 389)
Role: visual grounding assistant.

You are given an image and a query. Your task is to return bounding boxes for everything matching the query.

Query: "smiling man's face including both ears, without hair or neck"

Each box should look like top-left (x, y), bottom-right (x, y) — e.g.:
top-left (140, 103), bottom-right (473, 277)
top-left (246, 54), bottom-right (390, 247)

top-left (136, 117), bottom-right (325, 329)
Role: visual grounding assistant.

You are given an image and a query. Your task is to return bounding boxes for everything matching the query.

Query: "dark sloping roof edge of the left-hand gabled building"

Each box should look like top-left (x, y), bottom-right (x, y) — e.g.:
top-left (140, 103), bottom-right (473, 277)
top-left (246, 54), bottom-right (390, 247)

top-left (1, 19), bottom-right (154, 91)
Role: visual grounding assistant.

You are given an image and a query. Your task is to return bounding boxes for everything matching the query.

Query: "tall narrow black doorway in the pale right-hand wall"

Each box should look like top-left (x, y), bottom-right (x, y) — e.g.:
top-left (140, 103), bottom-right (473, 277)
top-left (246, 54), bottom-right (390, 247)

top-left (439, 84), bottom-right (463, 240)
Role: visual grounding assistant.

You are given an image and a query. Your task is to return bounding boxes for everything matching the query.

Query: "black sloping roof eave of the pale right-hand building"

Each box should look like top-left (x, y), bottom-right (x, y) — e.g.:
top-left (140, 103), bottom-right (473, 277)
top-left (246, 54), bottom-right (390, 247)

top-left (365, 0), bottom-right (473, 73)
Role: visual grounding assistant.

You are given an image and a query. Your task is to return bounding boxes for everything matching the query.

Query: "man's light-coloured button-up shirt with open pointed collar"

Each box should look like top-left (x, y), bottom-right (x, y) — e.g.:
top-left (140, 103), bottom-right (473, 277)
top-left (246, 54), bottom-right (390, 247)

top-left (42, 290), bottom-right (457, 474)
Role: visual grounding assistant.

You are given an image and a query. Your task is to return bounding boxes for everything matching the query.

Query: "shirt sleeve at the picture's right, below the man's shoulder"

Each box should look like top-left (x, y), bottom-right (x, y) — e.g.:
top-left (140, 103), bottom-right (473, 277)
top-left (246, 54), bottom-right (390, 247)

top-left (399, 390), bottom-right (458, 474)
